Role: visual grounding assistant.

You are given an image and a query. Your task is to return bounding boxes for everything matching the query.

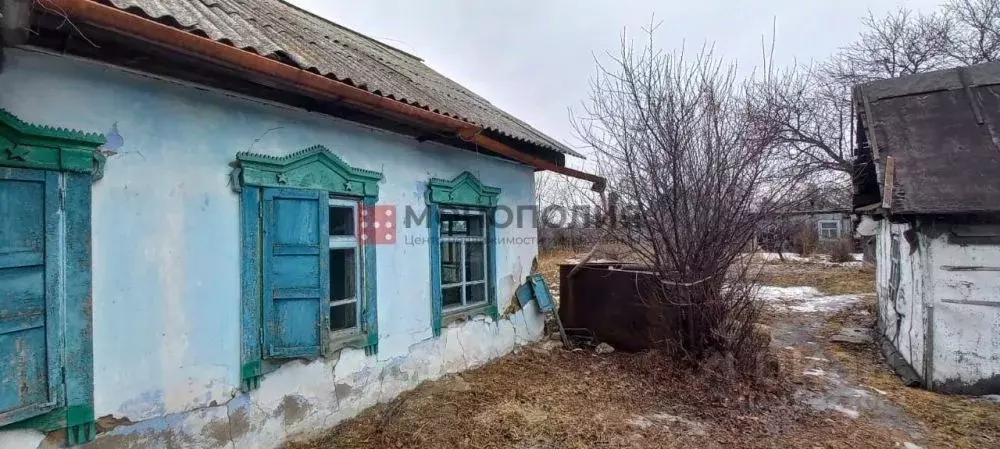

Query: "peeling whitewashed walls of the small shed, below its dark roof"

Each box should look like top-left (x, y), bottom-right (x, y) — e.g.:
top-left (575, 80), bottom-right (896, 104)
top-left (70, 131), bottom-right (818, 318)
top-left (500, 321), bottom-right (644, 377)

top-left (876, 220), bottom-right (1000, 394)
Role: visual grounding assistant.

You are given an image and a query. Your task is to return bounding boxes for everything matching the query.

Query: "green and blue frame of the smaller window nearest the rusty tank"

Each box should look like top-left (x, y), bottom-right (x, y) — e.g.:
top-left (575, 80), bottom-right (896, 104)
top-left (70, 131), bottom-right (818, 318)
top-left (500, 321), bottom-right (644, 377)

top-left (425, 172), bottom-right (501, 337)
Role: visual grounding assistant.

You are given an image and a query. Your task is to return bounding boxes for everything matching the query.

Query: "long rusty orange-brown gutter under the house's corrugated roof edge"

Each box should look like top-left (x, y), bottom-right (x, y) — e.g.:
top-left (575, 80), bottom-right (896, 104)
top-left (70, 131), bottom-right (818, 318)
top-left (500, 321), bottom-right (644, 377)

top-left (45, 0), bottom-right (605, 192)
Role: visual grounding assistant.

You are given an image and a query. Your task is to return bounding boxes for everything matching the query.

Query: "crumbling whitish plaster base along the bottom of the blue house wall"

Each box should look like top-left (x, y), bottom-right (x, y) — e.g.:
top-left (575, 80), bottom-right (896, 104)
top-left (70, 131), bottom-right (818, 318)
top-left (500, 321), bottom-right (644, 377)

top-left (69, 303), bottom-right (543, 449)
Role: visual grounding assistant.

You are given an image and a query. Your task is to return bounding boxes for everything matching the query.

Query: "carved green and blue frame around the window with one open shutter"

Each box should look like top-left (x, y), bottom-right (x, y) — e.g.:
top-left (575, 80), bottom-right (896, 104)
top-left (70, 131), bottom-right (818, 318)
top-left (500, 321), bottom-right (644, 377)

top-left (230, 145), bottom-right (383, 391)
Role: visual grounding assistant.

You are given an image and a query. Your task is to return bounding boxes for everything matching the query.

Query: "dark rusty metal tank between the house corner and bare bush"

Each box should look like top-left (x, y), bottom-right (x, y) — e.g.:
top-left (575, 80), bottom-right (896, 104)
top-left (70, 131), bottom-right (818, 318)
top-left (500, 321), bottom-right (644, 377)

top-left (559, 263), bottom-right (672, 352)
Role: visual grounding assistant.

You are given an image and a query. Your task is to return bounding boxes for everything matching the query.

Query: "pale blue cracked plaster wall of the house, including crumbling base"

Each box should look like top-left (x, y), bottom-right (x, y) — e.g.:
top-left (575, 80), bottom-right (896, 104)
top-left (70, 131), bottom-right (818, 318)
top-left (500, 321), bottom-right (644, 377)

top-left (0, 49), bottom-right (542, 448)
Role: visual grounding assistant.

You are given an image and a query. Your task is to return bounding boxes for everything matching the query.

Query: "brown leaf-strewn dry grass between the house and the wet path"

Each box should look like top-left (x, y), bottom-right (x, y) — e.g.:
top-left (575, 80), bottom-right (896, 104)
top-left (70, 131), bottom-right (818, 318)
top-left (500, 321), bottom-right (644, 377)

top-left (287, 347), bottom-right (898, 449)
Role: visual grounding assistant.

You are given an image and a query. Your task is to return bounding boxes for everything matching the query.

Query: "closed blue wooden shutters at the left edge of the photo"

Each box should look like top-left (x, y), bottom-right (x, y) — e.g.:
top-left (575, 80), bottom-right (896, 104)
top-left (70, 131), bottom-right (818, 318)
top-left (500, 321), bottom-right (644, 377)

top-left (0, 168), bottom-right (62, 425)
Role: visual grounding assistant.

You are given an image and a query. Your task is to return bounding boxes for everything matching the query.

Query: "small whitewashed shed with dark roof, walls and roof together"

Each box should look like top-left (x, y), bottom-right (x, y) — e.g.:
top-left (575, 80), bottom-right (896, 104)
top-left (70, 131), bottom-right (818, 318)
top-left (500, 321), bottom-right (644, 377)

top-left (854, 63), bottom-right (1000, 394)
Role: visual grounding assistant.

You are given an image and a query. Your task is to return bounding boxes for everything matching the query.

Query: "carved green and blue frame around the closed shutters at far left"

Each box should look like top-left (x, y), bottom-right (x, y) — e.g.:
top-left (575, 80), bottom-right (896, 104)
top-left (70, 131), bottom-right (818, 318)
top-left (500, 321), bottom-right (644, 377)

top-left (0, 109), bottom-right (105, 445)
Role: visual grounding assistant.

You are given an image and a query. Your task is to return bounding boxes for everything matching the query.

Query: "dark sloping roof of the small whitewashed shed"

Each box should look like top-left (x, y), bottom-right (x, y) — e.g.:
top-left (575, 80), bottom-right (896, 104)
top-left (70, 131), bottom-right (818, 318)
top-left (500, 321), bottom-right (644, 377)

top-left (855, 63), bottom-right (1000, 214)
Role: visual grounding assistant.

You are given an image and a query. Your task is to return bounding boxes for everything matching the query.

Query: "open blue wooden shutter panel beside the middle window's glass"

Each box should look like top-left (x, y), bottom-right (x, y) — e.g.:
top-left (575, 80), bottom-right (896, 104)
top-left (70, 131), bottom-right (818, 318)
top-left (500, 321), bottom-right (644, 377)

top-left (262, 189), bottom-right (330, 358)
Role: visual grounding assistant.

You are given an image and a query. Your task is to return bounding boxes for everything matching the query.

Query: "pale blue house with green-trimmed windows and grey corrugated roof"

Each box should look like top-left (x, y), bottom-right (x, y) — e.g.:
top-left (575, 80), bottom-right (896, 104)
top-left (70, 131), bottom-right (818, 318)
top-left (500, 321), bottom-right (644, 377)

top-left (0, 0), bottom-right (603, 449)
